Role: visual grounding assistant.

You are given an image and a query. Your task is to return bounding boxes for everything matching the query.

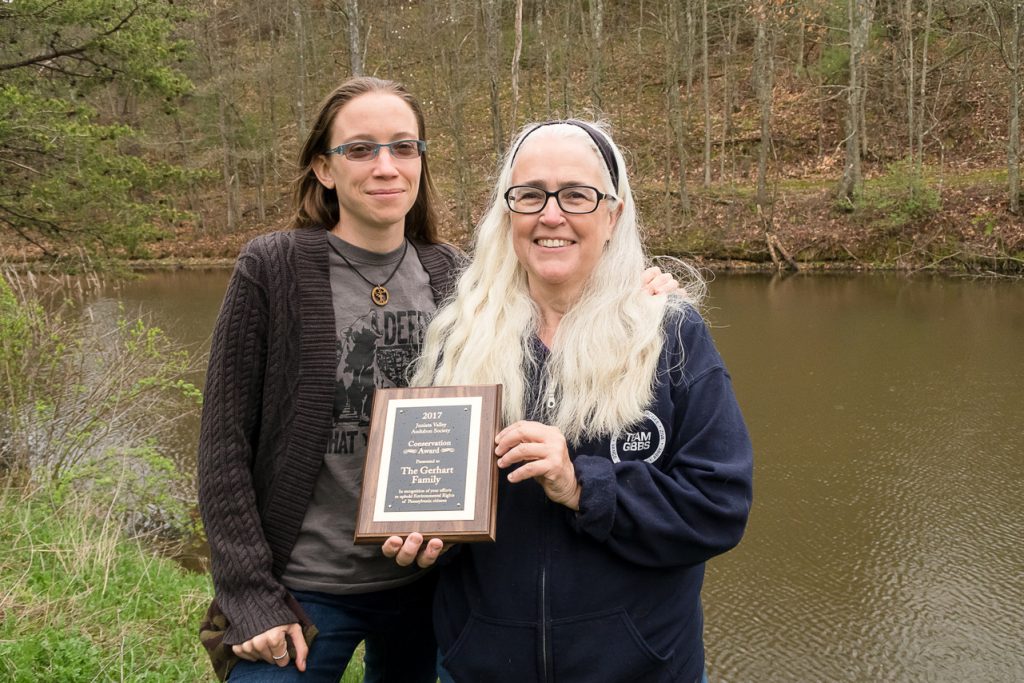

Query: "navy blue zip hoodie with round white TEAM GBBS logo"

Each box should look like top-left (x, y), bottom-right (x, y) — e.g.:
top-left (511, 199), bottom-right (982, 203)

top-left (434, 309), bottom-right (753, 683)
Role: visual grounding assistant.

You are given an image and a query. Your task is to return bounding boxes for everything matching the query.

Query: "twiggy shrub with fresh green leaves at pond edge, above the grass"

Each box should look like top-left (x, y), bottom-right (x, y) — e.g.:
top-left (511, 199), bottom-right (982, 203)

top-left (0, 270), bottom-right (202, 537)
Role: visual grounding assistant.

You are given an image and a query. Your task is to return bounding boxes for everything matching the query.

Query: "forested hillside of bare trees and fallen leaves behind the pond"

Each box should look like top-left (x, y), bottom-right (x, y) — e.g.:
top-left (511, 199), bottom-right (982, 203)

top-left (0, 0), bottom-right (1024, 273)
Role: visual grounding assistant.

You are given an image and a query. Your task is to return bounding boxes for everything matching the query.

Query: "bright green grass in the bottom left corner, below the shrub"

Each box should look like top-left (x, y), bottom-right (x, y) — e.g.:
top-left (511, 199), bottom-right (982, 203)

top-left (0, 481), bottom-right (213, 683)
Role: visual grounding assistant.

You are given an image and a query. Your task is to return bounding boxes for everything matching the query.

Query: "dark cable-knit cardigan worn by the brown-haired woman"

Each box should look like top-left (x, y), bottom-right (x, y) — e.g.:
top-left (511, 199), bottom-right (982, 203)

top-left (198, 228), bottom-right (459, 645)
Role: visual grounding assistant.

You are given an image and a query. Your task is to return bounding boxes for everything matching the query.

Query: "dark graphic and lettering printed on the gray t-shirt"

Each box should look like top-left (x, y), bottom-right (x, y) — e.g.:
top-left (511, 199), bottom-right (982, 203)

top-left (328, 307), bottom-right (427, 455)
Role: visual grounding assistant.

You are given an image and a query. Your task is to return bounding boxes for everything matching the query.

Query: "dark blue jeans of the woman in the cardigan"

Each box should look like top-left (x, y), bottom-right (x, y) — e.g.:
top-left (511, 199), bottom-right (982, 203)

top-left (228, 572), bottom-right (437, 683)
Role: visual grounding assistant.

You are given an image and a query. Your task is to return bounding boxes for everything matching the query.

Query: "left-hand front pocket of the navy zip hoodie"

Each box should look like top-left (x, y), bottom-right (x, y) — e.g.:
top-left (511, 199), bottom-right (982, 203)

top-left (441, 613), bottom-right (538, 683)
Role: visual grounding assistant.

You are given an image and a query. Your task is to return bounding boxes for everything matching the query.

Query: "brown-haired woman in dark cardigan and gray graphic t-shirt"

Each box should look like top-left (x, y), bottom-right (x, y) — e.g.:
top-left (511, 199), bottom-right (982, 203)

top-left (199, 78), bottom-right (459, 682)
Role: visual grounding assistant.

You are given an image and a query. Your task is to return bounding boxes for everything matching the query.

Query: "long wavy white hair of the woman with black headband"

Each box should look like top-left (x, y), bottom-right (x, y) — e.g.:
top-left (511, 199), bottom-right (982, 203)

top-left (412, 122), bottom-right (705, 443)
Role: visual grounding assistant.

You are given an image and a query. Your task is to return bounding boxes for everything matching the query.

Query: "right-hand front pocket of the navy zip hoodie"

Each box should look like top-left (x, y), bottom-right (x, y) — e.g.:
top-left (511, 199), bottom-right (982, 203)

top-left (551, 609), bottom-right (674, 683)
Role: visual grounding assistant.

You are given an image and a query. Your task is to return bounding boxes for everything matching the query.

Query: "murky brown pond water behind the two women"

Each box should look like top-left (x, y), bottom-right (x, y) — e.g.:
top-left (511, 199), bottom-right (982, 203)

top-left (97, 270), bottom-right (1024, 683)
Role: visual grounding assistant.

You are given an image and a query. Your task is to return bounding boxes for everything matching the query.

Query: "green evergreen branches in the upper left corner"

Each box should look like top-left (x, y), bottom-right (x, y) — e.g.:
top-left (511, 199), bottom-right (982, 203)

top-left (0, 0), bottom-right (197, 256)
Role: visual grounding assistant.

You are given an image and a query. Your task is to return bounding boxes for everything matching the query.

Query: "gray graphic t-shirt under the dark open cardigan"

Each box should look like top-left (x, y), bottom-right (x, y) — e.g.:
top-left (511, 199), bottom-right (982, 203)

top-left (282, 234), bottom-right (435, 594)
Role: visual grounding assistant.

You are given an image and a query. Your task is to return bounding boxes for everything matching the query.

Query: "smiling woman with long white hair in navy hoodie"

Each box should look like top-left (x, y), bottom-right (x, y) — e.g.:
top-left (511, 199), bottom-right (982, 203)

top-left (383, 120), bottom-right (753, 683)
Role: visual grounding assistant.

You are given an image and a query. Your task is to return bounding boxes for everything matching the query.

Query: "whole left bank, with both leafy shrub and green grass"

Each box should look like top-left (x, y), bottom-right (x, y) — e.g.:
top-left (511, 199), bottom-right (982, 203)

top-left (0, 270), bottom-right (376, 683)
